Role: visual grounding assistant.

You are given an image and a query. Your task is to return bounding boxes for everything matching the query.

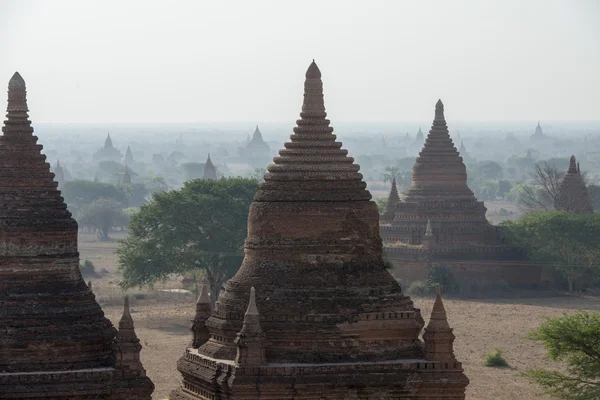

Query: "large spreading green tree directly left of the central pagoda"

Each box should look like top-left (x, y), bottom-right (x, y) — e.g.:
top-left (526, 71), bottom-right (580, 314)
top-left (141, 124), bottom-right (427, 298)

top-left (117, 178), bottom-right (258, 300)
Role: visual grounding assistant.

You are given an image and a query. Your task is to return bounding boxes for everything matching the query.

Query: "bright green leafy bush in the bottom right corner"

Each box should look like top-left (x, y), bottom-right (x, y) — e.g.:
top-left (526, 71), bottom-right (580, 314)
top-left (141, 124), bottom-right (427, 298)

top-left (525, 311), bottom-right (600, 400)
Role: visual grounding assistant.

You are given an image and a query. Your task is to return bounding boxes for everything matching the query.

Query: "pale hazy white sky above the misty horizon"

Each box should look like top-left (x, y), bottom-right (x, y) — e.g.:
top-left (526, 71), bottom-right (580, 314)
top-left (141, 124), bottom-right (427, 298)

top-left (0, 0), bottom-right (600, 125)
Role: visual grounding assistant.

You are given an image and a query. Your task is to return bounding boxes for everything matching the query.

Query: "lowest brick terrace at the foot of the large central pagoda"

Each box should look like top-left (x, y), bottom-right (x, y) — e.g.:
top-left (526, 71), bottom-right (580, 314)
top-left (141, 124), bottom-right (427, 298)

top-left (169, 349), bottom-right (469, 400)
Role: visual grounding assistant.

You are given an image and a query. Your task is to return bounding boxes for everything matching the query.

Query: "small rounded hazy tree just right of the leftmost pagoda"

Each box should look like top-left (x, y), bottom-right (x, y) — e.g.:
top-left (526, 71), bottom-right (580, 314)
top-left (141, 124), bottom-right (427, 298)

top-left (79, 198), bottom-right (129, 239)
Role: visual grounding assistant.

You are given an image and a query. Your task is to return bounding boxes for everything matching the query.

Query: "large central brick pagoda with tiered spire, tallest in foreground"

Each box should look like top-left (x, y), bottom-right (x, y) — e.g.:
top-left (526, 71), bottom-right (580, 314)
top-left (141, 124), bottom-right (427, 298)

top-left (170, 61), bottom-right (469, 400)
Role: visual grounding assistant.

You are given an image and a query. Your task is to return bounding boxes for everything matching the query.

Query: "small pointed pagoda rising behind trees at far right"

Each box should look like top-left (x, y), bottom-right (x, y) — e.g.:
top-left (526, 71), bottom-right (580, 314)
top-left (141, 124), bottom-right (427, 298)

top-left (557, 155), bottom-right (594, 214)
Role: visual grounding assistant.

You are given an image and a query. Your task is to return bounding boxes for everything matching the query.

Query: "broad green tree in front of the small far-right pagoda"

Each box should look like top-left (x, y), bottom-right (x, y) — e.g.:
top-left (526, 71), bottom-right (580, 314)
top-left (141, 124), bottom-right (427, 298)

top-left (502, 211), bottom-right (600, 290)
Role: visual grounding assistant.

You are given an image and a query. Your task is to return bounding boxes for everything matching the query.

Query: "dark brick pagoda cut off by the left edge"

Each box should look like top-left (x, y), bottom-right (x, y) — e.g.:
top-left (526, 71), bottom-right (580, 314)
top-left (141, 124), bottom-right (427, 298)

top-left (0, 73), bottom-right (154, 400)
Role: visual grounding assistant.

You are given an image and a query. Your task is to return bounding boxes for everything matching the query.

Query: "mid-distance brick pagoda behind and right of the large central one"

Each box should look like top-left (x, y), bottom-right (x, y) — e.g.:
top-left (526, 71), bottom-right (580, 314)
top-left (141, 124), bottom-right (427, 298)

top-left (380, 100), bottom-right (541, 286)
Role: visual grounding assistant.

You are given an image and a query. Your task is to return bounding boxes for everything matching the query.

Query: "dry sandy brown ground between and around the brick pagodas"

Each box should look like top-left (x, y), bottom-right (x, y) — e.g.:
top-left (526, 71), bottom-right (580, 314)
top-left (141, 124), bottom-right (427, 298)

top-left (80, 233), bottom-right (600, 400)
